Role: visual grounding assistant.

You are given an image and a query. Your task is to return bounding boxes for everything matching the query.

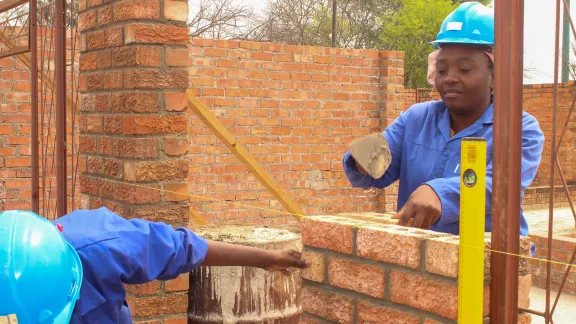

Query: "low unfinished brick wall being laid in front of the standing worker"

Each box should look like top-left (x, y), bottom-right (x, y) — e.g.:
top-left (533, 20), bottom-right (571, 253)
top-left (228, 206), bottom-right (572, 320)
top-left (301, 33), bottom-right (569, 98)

top-left (302, 213), bottom-right (531, 324)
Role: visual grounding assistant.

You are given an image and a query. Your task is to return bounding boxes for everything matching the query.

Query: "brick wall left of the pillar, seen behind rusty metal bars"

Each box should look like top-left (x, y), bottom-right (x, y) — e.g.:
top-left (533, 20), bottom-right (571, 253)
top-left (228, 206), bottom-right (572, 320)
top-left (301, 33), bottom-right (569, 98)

top-left (0, 28), bottom-right (79, 219)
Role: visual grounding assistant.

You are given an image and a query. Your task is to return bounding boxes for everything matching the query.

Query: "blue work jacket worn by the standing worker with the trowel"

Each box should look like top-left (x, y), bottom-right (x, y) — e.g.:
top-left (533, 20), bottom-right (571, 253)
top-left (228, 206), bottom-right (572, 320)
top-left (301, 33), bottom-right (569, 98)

top-left (343, 100), bottom-right (544, 236)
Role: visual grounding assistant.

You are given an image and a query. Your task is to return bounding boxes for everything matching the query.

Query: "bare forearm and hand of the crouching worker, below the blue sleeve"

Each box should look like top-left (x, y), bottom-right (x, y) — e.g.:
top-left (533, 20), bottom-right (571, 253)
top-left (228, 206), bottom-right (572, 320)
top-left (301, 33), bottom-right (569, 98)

top-left (202, 241), bottom-right (307, 274)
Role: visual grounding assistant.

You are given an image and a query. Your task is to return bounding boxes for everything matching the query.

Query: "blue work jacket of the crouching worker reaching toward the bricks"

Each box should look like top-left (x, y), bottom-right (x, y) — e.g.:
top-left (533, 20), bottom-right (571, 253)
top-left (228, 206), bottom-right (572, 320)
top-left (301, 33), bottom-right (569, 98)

top-left (54, 208), bottom-right (208, 324)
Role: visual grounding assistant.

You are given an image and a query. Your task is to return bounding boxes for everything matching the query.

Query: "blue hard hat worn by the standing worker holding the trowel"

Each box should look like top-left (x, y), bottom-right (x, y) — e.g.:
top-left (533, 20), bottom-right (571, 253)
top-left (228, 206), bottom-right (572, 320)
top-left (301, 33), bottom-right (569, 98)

top-left (431, 2), bottom-right (494, 49)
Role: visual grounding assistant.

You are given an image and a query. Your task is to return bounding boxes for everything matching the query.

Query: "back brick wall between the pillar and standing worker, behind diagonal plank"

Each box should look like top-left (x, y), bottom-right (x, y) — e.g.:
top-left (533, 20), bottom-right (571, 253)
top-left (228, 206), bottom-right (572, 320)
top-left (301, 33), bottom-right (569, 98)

top-left (188, 39), bottom-right (403, 223)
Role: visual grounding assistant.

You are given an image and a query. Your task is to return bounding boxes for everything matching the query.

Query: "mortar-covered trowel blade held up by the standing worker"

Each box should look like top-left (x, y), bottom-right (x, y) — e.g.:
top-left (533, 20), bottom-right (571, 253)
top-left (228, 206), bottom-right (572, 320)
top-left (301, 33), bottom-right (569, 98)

top-left (348, 133), bottom-right (392, 179)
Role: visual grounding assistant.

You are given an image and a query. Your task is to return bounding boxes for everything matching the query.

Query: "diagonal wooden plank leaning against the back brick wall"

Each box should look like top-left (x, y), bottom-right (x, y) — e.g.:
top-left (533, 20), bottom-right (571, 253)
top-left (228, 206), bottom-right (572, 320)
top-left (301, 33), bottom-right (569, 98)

top-left (187, 89), bottom-right (306, 221)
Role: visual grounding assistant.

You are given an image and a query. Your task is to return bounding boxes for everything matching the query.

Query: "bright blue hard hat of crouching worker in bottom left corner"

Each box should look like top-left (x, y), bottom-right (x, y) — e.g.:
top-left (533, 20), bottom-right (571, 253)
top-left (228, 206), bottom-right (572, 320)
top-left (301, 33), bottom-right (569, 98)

top-left (0, 211), bottom-right (82, 324)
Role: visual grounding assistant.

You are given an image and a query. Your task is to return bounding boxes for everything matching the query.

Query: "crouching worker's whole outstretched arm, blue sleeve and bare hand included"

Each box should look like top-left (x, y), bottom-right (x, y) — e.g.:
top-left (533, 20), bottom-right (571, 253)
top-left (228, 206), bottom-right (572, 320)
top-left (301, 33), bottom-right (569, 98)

top-left (113, 212), bottom-right (306, 284)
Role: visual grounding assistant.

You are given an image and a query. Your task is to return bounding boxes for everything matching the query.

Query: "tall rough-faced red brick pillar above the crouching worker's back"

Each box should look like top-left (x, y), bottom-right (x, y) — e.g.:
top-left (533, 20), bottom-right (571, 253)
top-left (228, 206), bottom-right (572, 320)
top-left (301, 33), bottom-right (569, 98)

top-left (79, 0), bottom-right (189, 225)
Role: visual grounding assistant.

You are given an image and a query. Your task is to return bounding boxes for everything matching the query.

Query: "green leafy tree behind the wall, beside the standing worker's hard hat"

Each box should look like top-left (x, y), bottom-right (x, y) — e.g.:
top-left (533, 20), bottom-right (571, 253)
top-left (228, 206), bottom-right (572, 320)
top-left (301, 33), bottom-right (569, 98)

top-left (381, 0), bottom-right (459, 88)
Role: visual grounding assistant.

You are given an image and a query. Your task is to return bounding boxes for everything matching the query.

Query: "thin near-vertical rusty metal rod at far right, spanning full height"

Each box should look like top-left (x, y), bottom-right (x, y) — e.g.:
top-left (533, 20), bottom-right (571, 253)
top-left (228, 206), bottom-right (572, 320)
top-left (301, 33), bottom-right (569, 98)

top-left (546, 0), bottom-right (560, 324)
